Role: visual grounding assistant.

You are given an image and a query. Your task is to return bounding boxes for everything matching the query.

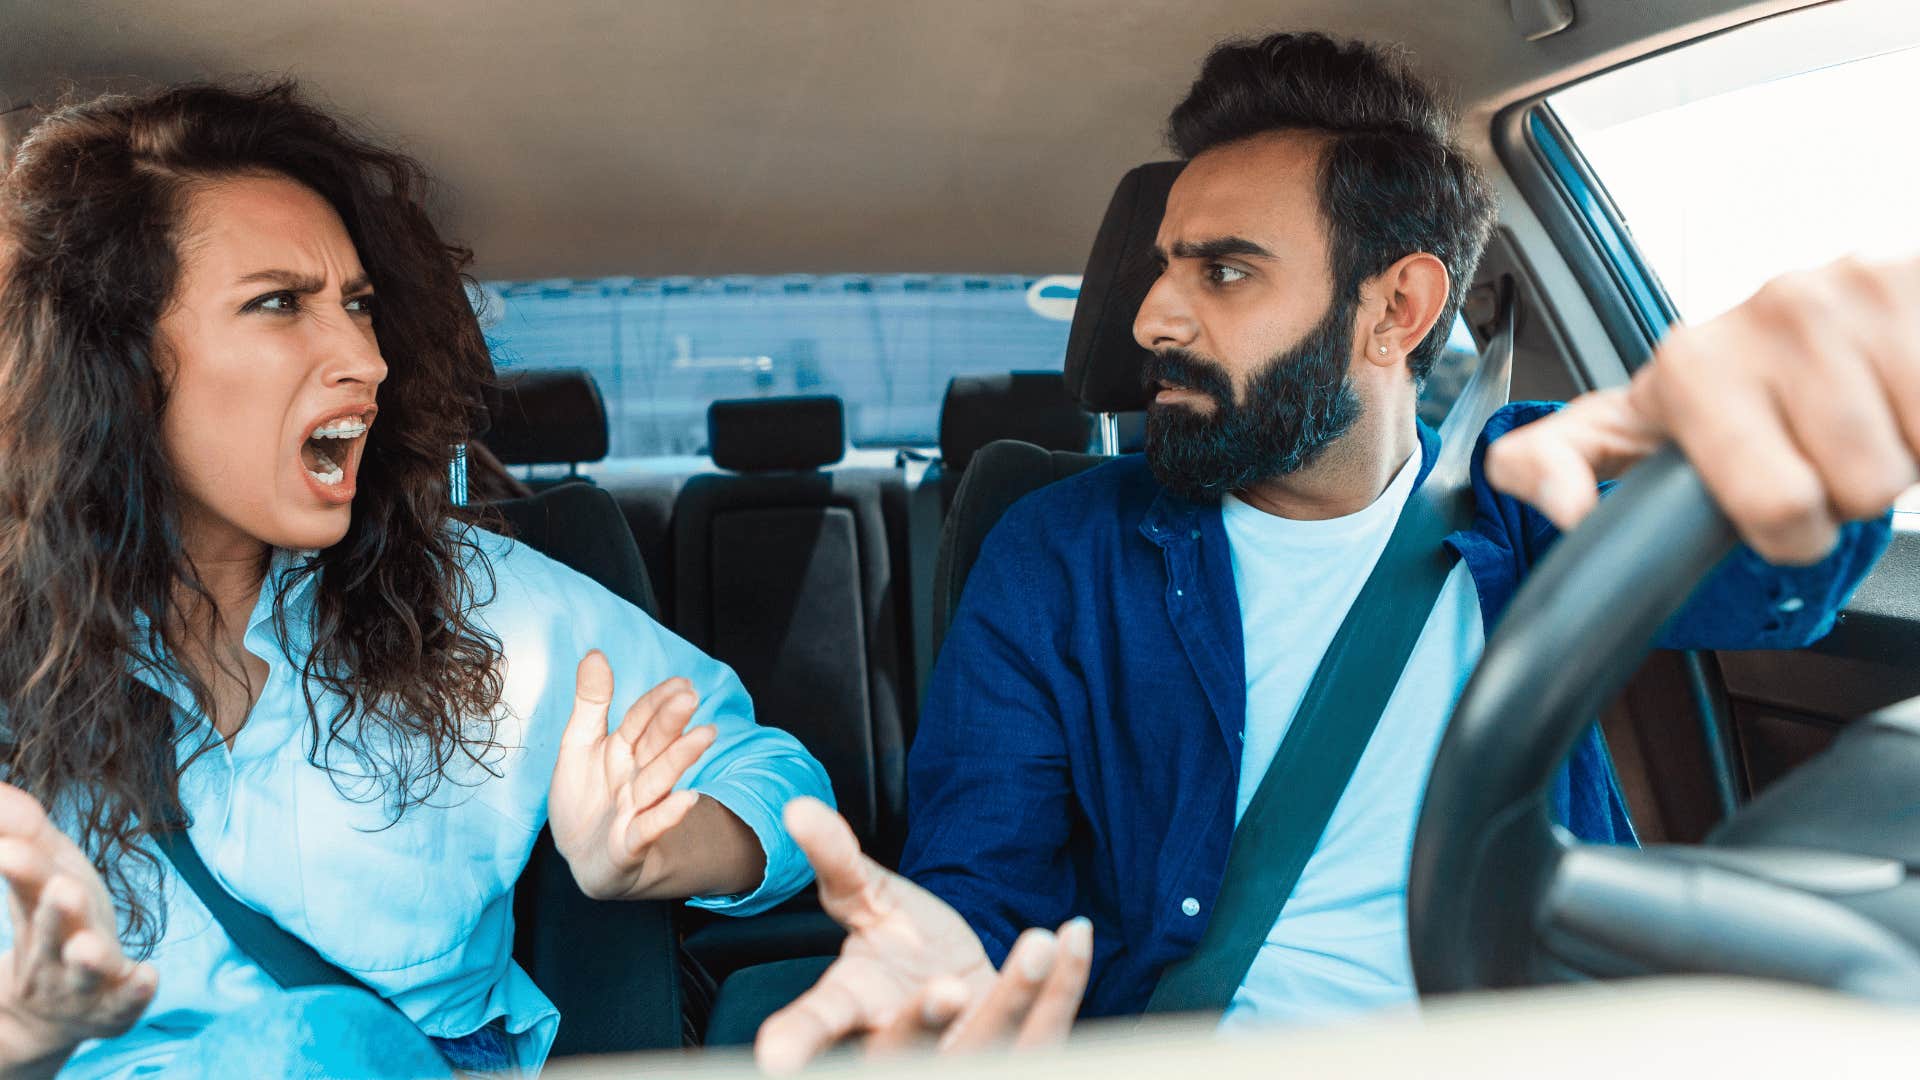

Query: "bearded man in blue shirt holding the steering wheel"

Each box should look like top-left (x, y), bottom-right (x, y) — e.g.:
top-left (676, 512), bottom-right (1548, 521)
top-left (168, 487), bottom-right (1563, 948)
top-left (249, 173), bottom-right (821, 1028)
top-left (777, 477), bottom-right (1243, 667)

top-left (758, 35), bottom-right (1920, 1068)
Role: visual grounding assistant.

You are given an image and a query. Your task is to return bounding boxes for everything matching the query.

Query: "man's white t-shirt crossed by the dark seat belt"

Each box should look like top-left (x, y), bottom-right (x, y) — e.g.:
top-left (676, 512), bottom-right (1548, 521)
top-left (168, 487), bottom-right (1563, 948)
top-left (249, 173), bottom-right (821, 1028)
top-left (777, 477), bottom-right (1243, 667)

top-left (1223, 454), bottom-right (1486, 1028)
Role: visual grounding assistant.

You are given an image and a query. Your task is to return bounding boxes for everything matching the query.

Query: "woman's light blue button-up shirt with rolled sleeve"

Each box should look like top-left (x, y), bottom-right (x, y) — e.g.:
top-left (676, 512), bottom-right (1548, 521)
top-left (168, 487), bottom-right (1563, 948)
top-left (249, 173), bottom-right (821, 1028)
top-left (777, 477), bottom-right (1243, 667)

top-left (0, 532), bottom-right (833, 1076)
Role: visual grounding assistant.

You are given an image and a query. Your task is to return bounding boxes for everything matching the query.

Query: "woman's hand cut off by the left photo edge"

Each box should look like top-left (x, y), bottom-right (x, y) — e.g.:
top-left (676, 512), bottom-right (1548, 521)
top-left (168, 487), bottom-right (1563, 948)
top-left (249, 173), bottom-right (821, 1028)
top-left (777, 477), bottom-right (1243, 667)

top-left (0, 784), bottom-right (159, 1076)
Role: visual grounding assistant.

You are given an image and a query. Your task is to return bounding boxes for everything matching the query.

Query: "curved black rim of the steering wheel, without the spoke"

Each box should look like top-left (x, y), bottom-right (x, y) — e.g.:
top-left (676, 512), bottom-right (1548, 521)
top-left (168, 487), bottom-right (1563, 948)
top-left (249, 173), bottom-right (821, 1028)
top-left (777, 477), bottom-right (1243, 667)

top-left (1407, 448), bottom-right (1736, 994)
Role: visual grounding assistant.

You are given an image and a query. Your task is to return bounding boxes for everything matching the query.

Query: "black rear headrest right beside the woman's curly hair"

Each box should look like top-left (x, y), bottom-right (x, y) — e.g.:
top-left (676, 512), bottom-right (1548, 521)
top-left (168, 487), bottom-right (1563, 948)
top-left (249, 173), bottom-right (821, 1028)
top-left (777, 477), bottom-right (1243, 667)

top-left (482, 367), bottom-right (607, 465)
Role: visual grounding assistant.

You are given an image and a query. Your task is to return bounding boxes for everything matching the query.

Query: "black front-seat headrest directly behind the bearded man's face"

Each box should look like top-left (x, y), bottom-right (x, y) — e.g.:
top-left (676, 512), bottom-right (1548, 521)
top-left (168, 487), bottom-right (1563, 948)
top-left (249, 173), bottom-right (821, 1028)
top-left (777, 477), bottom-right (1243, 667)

top-left (1066, 161), bottom-right (1187, 413)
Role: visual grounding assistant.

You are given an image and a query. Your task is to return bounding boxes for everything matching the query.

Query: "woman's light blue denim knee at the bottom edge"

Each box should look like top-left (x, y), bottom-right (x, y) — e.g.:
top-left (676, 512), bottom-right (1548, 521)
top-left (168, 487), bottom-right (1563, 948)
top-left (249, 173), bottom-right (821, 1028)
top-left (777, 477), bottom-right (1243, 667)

top-left (167, 986), bottom-right (453, 1080)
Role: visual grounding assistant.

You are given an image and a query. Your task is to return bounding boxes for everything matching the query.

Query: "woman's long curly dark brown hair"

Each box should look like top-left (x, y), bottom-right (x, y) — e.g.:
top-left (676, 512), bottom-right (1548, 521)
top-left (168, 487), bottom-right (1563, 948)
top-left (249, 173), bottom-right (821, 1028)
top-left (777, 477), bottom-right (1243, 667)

top-left (0, 83), bottom-right (501, 951)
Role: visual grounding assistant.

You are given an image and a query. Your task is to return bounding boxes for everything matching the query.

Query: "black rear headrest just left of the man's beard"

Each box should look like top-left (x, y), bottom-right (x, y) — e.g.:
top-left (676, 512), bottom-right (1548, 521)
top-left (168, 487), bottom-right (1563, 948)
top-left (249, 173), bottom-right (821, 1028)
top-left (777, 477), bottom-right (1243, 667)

top-left (941, 371), bottom-right (1092, 473)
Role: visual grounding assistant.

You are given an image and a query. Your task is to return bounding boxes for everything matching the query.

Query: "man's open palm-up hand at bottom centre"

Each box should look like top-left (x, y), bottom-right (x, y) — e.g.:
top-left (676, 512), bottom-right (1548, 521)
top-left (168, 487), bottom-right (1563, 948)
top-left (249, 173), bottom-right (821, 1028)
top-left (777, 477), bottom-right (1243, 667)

top-left (753, 799), bottom-right (1092, 1072)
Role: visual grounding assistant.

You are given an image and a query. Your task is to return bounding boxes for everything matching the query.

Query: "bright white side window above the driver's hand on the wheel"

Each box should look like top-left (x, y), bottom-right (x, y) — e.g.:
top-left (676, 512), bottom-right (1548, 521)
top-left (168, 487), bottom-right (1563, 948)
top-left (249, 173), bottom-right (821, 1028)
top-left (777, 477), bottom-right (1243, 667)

top-left (1548, 0), bottom-right (1920, 511)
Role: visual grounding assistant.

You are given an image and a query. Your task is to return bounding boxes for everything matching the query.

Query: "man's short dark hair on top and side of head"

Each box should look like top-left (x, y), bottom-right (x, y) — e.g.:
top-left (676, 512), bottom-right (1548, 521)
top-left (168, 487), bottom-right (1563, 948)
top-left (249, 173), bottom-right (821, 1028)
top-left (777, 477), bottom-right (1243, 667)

top-left (1167, 33), bottom-right (1494, 380)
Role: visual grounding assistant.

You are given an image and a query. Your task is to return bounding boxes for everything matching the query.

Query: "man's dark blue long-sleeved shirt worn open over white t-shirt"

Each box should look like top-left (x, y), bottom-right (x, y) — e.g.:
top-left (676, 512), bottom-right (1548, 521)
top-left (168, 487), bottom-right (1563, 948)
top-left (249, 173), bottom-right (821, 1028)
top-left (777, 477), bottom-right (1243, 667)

top-left (902, 404), bottom-right (1889, 1017)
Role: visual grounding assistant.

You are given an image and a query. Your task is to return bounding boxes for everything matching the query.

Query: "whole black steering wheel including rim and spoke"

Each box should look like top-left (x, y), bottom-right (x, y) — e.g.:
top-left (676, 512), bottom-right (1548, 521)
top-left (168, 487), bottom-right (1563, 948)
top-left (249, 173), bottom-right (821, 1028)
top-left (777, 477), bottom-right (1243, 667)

top-left (1407, 450), bottom-right (1920, 1003)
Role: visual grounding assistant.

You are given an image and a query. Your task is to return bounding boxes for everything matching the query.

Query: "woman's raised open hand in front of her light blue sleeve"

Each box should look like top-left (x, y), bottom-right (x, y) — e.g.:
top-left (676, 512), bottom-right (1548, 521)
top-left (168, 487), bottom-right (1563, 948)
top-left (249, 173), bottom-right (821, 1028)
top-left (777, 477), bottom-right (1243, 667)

top-left (547, 650), bottom-right (732, 899)
